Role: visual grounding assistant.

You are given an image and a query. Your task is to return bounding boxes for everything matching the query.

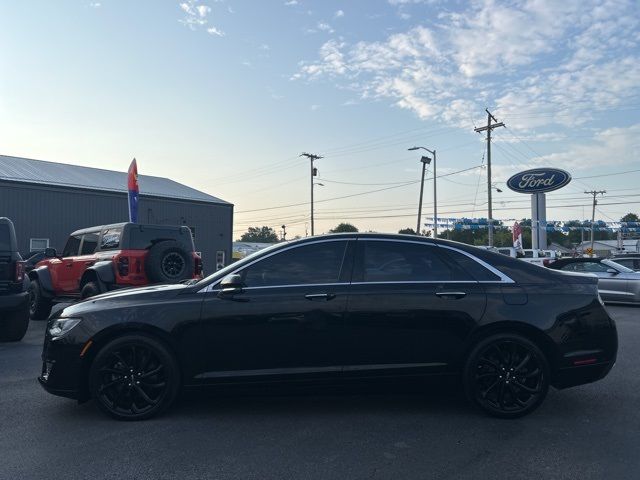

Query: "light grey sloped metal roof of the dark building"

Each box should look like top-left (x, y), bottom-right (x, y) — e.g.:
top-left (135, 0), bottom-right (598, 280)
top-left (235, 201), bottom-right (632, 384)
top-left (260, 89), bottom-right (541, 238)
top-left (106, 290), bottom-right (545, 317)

top-left (0, 155), bottom-right (230, 205)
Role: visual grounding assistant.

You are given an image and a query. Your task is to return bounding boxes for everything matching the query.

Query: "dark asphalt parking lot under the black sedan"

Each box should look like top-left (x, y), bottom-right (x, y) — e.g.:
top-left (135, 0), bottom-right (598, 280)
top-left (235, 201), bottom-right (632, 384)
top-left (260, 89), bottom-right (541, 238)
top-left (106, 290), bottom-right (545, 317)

top-left (0, 307), bottom-right (640, 480)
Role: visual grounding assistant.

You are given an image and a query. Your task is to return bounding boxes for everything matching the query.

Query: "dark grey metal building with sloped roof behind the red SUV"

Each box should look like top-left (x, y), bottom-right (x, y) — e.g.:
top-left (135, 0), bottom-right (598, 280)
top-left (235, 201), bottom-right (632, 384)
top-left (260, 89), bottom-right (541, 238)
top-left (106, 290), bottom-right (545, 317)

top-left (0, 155), bottom-right (233, 274)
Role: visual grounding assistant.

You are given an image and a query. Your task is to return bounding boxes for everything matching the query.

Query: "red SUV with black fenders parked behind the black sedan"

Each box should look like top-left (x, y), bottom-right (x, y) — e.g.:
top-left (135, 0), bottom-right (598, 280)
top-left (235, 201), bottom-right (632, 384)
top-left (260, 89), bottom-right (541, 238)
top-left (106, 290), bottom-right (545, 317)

top-left (29, 223), bottom-right (202, 320)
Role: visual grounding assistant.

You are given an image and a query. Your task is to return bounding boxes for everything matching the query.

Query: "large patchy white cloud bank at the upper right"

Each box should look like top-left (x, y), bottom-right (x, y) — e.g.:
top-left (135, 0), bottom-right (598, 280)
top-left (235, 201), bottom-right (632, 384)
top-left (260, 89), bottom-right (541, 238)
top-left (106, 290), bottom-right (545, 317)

top-left (292, 0), bottom-right (640, 129)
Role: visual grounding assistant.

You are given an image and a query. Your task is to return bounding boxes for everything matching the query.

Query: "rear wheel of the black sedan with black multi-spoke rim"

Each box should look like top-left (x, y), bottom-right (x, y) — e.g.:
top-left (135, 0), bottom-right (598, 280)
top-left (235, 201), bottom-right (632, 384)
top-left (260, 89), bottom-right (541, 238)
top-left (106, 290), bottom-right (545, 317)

top-left (463, 333), bottom-right (549, 418)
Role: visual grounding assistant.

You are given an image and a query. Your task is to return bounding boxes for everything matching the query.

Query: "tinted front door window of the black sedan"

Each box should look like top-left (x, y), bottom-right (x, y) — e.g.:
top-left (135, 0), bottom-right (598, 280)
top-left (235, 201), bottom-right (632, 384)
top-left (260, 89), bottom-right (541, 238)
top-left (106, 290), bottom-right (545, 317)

top-left (240, 241), bottom-right (347, 287)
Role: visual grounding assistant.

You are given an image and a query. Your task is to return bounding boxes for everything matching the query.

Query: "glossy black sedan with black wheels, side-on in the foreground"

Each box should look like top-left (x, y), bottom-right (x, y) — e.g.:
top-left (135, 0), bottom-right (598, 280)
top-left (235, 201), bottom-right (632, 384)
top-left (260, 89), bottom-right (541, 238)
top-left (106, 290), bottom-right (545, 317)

top-left (39, 234), bottom-right (617, 420)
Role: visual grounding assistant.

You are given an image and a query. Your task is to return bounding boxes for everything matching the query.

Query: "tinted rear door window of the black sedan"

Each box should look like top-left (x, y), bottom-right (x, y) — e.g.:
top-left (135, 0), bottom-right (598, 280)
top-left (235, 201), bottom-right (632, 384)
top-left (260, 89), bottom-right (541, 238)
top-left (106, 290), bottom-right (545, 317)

top-left (358, 241), bottom-right (474, 282)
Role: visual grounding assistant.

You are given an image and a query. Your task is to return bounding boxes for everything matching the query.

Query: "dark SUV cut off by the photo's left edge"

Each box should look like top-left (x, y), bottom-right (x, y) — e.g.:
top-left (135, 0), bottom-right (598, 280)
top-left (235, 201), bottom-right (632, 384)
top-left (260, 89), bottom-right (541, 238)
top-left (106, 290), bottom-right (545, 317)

top-left (0, 217), bottom-right (29, 342)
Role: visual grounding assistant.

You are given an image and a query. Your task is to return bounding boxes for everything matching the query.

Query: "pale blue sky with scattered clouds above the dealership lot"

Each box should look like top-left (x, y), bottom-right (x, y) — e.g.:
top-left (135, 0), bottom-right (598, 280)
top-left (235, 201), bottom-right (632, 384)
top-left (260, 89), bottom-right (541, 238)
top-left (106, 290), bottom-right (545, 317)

top-left (0, 0), bottom-right (640, 238)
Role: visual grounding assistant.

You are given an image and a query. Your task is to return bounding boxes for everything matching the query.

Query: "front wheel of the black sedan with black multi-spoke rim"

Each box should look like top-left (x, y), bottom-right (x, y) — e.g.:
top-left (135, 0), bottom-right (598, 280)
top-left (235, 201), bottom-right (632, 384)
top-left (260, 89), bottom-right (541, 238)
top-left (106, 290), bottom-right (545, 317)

top-left (89, 334), bottom-right (180, 421)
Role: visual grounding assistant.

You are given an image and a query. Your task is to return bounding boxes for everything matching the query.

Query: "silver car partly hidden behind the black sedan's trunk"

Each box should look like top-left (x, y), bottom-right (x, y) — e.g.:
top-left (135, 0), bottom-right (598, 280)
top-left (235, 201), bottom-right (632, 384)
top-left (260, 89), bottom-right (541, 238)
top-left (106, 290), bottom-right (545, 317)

top-left (549, 258), bottom-right (640, 303)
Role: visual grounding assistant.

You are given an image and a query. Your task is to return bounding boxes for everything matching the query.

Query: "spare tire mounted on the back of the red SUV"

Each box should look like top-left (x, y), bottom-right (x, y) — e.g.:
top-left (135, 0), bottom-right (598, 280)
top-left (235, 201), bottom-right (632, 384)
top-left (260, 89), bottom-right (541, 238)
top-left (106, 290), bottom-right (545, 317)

top-left (145, 240), bottom-right (195, 283)
